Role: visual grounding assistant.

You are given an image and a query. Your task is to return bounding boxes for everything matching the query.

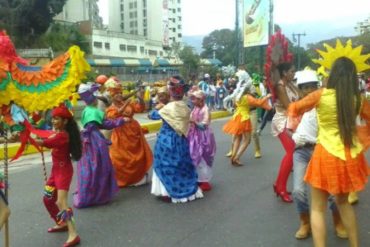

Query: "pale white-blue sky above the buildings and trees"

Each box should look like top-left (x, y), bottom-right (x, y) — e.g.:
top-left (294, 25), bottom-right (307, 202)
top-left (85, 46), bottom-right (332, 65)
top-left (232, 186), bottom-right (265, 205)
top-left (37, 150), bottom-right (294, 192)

top-left (99, 0), bottom-right (370, 44)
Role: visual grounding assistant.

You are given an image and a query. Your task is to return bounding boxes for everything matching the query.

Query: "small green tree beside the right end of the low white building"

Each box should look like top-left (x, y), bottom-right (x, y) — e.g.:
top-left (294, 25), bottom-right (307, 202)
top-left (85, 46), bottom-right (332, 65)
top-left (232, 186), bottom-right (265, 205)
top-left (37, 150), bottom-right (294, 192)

top-left (179, 45), bottom-right (200, 77)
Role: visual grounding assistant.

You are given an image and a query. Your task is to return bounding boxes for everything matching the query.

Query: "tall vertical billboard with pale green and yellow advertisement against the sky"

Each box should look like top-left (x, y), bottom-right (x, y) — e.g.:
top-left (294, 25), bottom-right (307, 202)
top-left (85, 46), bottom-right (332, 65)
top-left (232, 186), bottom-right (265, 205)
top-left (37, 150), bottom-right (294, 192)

top-left (243, 0), bottom-right (270, 47)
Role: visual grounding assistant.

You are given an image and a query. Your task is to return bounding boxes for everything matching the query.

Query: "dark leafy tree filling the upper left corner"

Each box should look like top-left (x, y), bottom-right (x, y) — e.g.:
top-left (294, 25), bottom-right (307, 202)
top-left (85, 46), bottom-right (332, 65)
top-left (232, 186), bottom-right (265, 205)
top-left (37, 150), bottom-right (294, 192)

top-left (0, 0), bottom-right (67, 47)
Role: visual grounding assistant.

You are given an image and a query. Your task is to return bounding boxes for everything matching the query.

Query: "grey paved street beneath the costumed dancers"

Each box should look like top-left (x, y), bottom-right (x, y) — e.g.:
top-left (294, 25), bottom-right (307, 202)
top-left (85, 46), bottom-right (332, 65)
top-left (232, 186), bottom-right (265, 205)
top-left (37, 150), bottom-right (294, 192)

top-left (0, 119), bottom-right (370, 247)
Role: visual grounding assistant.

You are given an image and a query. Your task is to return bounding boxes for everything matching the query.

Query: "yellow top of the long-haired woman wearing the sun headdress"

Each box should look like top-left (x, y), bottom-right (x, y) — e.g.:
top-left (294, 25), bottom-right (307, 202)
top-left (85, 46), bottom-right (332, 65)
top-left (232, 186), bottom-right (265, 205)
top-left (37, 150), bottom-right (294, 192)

top-left (317, 89), bottom-right (363, 160)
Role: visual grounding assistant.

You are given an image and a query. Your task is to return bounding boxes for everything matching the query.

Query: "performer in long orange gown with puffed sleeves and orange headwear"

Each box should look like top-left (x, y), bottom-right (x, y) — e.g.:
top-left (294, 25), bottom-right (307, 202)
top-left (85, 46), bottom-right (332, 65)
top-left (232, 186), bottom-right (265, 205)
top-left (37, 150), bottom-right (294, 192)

top-left (106, 84), bottom-right (153, 187)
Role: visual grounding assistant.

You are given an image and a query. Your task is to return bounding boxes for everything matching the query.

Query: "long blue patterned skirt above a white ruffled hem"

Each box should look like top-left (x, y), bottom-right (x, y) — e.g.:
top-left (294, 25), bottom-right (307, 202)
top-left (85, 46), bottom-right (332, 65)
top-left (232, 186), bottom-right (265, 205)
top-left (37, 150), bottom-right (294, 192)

top-left (153, 121), bottom-right (198, 199)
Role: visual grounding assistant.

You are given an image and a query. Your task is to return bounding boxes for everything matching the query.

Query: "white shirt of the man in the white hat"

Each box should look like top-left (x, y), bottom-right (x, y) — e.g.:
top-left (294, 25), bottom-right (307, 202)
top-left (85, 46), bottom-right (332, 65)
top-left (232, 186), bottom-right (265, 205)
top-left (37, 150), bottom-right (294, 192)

top-left (292, 108), bottom-right (318, 147)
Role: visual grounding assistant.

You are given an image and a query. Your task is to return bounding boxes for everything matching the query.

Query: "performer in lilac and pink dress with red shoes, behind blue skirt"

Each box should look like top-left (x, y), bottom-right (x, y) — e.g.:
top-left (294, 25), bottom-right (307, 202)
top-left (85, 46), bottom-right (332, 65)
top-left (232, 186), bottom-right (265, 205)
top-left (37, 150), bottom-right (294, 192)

top-left (188, 89), bottom-right (216, 191)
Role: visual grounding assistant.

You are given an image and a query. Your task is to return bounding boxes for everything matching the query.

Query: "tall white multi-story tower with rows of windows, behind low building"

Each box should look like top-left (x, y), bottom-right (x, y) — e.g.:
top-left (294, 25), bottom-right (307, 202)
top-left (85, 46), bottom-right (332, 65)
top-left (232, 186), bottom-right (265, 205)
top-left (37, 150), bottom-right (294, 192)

top-left (108, 0), bottom-right (182, 48)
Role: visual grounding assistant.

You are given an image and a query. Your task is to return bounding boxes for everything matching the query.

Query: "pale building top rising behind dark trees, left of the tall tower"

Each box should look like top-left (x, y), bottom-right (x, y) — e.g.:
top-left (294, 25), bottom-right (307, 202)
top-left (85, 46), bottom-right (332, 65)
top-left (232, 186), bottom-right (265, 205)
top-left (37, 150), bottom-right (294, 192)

top-left (54, 0), bottom-right (103, 29)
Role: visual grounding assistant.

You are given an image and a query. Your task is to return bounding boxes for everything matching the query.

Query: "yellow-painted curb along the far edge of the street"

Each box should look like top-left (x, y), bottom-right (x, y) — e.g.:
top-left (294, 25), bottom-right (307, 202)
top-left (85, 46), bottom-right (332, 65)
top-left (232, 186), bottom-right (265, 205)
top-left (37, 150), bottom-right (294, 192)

top-left (0, 111), bottom-right (231, 160)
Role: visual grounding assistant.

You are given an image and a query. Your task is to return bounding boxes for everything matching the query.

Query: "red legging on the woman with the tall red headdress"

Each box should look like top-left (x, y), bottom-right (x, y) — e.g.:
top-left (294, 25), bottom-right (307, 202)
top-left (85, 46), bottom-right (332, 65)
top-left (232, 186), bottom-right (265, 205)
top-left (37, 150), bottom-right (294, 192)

top-left (275, 130), bottom-right (295, 192)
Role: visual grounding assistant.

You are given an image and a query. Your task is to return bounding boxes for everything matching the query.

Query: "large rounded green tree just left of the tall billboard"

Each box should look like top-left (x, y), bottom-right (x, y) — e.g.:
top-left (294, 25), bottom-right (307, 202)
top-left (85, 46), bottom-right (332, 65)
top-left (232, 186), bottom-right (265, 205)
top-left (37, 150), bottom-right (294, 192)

top-left (201, 29), bottom-right (237, 65)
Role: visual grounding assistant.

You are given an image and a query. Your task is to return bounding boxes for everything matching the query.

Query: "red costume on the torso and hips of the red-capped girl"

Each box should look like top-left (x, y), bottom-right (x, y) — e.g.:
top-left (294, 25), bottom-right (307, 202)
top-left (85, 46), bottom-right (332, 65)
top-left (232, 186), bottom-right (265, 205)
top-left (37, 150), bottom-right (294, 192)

top-left (43, 132), bottom-right (73, 191)
